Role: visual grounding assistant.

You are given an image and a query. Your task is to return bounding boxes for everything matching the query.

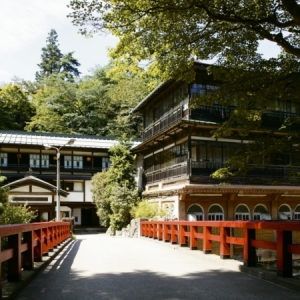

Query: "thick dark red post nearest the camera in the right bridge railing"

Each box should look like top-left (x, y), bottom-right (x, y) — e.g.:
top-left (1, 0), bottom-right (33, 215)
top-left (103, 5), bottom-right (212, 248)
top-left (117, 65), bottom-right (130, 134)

top-left (277, 230), bottom-right (293, 277)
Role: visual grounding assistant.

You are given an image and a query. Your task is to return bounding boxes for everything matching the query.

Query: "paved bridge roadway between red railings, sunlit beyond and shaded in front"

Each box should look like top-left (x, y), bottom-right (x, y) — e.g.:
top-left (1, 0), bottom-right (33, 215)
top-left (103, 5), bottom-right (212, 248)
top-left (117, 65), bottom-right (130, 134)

top-left (16, 234), bottom-right (300, 300)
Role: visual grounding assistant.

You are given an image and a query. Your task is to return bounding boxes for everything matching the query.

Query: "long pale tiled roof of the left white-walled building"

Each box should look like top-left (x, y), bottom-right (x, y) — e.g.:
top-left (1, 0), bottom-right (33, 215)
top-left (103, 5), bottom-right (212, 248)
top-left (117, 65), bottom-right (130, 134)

top-left (0, 130), bottom-right (140, 149)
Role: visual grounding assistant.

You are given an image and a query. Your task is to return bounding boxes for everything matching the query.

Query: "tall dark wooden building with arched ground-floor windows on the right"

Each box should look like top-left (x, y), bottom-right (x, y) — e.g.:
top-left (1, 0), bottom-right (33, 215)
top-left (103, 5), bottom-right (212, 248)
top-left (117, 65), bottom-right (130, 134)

top-left (133, 63), bottom-right (300, 220)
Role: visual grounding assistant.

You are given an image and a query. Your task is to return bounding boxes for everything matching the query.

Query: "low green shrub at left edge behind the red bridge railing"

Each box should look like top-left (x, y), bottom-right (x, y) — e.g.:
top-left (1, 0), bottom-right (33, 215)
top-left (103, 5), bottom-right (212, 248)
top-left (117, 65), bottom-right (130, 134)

top-left (0, 175), bottom-right (36, 225)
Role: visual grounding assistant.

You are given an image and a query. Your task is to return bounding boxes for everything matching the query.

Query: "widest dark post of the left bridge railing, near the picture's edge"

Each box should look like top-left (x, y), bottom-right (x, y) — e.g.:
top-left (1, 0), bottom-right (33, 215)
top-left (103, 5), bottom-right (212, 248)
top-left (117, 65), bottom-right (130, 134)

top-left (7, 233), bottom-right (22, 281)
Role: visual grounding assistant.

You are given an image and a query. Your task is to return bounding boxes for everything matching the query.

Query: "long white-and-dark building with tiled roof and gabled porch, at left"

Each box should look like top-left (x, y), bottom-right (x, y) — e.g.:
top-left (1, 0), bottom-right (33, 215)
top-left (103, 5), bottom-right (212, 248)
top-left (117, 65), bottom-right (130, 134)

top-left (0, 130), bottom-right (138, 226)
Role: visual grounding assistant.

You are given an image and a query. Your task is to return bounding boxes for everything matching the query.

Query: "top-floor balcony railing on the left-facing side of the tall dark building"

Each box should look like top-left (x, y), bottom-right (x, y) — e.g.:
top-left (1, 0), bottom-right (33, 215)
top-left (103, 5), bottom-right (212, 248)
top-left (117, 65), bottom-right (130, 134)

top-left (143, 105), bottom-right (183, 141)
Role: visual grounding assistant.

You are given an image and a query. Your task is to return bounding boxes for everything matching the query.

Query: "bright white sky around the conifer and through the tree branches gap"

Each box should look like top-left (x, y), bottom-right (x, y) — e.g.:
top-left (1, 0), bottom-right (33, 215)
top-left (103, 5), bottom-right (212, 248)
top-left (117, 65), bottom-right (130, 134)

top-left (0, 0), bottom-right (279, 86)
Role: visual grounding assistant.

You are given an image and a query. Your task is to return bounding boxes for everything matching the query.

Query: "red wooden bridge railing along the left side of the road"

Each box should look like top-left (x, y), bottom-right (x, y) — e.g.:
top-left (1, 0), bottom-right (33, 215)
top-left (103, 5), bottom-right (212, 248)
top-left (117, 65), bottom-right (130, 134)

top-left (0, 222), bottom-right (71, 289)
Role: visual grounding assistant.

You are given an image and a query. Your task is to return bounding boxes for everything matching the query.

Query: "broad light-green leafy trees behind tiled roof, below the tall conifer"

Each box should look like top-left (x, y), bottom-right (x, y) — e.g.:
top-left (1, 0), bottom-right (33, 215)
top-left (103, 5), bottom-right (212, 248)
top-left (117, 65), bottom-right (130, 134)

top-left (25, 65), bottom-right (147, 137)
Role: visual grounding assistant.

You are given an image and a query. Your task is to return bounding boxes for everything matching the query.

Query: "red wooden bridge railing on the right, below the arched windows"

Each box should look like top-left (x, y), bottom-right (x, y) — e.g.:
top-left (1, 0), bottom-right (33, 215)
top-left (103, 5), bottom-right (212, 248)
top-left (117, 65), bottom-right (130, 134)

top-left (141, 221), bottom-right (300, 277)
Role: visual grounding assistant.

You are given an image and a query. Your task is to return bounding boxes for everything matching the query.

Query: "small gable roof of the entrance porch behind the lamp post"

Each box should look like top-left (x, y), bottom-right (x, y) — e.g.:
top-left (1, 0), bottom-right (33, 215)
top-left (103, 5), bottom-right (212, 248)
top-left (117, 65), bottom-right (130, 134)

top-left (2, 175), bottom-right (70, 197)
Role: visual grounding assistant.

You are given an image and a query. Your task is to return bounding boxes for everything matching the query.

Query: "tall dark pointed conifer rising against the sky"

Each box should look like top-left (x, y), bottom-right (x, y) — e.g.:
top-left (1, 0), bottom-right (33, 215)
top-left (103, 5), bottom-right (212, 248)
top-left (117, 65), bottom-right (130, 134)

top-left (35, 29), bottom-right (80, 82)
